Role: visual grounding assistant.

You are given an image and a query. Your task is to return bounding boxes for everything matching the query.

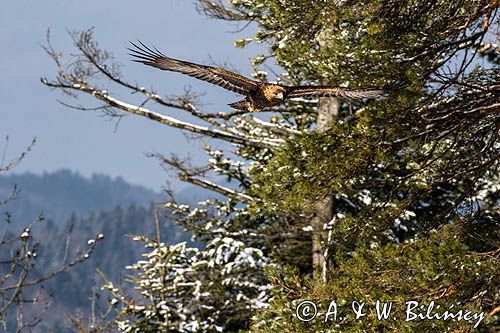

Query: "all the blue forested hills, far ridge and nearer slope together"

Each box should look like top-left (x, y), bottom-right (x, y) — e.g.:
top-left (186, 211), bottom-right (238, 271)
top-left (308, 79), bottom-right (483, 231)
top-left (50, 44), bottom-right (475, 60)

top-left (0, 170), bottom-right (192, 332)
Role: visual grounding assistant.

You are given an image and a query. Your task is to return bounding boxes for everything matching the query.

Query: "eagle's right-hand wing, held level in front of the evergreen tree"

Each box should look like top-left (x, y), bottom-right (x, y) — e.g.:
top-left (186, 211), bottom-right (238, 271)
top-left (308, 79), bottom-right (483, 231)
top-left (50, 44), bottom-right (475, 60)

top-left (287, 86), bottom-right (387, 99)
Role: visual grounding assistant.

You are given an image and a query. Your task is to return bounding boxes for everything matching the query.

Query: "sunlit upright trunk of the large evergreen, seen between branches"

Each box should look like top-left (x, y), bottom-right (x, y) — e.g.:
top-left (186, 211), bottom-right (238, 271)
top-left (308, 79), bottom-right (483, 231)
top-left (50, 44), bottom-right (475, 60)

top-left (311, 98), bottom-right (340, 280)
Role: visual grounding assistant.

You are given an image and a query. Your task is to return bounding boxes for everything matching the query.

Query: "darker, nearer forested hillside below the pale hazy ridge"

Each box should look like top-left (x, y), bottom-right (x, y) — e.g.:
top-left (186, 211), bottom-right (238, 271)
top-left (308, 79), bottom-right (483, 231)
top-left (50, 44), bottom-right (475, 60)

top-left (33, 204), bottom-right (189, 332)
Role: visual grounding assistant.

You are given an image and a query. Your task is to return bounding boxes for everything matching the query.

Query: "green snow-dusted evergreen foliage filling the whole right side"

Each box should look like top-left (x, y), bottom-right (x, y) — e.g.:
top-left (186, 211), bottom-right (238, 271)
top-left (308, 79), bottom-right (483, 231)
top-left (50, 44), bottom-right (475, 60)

top-left (201, 0), bottom-right (500, 332)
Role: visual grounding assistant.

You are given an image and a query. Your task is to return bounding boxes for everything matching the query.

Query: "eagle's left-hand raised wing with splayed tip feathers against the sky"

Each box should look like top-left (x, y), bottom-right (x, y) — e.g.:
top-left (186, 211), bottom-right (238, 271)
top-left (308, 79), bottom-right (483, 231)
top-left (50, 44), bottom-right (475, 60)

top-left (128, 41), bottom-right (258, 95)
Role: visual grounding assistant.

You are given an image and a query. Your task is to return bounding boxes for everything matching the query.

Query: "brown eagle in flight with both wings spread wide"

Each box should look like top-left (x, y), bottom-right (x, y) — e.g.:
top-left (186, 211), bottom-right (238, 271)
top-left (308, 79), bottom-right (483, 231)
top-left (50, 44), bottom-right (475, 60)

top-left (128, 41), bottom-right (388, 112)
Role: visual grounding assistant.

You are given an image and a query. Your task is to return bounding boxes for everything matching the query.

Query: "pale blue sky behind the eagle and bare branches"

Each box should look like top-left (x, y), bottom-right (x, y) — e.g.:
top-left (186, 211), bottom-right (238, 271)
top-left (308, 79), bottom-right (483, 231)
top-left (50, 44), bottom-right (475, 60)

top-left (0, 0), bottom-right (264, 190)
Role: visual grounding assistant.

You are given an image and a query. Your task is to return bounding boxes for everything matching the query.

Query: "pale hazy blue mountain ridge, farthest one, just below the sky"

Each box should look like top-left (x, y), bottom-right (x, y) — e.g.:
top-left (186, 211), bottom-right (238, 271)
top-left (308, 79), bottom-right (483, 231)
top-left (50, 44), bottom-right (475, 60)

top-left (0, 169), bottom-right (162, 226)
